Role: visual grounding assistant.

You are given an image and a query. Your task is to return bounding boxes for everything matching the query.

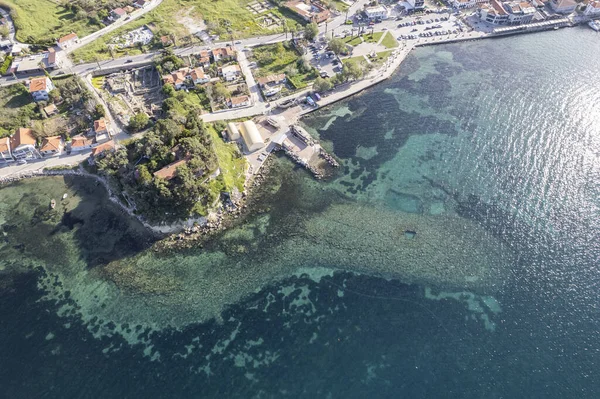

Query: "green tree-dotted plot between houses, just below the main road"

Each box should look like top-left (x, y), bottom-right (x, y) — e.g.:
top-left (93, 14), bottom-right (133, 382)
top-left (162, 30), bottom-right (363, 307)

top-left (252, 42), bottom-right (318, 89)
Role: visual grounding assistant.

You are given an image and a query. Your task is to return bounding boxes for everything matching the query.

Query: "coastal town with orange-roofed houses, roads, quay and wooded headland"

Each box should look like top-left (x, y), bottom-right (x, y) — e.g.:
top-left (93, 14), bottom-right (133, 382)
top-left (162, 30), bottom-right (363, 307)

top-left (0, 0), bottom-right (600, 227)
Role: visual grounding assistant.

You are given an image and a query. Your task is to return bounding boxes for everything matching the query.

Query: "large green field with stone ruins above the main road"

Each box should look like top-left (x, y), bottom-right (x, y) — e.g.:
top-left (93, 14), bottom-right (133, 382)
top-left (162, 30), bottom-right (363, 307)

top-left (71, 0), bottom-right (301, 62)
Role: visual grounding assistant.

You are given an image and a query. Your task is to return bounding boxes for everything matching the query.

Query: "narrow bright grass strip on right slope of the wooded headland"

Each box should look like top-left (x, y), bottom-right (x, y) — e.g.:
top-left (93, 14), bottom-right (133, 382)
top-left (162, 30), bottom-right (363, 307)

top-left (207, 126), bottom-right (246, 192)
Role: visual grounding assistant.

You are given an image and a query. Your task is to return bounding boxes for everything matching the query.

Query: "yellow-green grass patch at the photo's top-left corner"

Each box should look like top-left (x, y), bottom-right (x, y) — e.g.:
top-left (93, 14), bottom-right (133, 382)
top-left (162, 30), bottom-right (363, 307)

top-left (0, 0), bottom-right (101, 44)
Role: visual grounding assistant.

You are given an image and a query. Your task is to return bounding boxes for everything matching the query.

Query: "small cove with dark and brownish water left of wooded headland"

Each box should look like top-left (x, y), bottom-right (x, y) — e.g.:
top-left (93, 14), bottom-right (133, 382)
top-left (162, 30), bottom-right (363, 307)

top-left (0, 176), bottom-right (154, 267)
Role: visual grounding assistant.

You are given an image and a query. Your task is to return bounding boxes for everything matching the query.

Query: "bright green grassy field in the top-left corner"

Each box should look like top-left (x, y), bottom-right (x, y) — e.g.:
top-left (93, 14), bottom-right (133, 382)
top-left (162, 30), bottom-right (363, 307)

top-left (0, 0), bottom-right (129, 45)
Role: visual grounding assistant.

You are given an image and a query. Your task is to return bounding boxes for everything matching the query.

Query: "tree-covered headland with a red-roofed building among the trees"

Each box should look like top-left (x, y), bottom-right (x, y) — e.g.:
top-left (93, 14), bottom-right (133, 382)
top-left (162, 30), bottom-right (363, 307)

top-left (96, 90), bottom-right (245, 221)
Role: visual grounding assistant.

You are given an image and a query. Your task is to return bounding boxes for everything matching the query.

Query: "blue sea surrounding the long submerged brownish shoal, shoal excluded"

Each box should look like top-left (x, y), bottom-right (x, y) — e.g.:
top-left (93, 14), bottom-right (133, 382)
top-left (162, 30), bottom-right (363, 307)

top-left (0, 29), bottom-right (600, 399)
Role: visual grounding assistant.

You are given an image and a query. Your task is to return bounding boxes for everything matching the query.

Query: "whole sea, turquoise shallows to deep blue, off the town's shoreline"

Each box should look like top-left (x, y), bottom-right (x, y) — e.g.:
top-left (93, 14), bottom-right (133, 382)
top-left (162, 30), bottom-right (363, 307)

top-left (0, 28), bottom-right (600, 398)
